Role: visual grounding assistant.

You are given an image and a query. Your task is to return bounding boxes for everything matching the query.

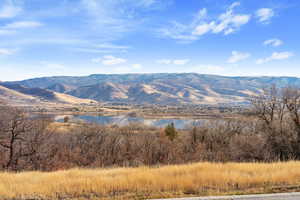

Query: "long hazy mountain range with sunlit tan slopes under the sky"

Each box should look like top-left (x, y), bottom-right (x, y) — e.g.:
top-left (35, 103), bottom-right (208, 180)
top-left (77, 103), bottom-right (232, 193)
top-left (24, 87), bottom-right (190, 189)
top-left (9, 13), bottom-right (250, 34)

top-left (0, 73), bottom-right (300, 105)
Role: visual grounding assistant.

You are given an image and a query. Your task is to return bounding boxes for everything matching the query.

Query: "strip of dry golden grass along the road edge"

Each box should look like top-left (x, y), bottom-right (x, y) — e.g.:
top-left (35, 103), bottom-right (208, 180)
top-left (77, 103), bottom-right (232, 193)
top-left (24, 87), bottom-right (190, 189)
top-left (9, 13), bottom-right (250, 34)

top-left (0, 162), bottom-right (300, 200)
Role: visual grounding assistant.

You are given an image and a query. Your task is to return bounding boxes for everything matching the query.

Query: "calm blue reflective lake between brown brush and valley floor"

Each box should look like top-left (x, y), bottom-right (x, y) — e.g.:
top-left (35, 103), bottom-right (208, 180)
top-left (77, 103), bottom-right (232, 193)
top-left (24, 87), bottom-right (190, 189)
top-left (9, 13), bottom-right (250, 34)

top-left (55, 115), bottom-right (207, 129)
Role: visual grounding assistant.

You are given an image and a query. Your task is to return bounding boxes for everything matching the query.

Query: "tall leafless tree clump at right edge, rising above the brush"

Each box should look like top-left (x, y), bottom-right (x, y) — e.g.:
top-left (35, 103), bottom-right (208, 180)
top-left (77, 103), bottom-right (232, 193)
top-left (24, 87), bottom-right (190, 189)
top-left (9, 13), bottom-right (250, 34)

top-left (252, 86), bottom-right (300, 160)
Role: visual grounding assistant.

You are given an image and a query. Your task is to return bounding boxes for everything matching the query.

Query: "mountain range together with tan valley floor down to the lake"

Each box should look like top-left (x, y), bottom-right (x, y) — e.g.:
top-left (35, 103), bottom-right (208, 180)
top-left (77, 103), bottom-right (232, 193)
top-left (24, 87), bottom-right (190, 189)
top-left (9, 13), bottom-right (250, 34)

top-left (0, 73), bottom-right (292, 122)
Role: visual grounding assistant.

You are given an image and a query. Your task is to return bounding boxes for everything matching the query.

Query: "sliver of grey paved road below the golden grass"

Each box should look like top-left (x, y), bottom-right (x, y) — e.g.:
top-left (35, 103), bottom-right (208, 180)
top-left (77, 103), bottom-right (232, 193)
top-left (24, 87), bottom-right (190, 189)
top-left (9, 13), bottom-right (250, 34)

top-left (151, 192), bottom-right (300, 200)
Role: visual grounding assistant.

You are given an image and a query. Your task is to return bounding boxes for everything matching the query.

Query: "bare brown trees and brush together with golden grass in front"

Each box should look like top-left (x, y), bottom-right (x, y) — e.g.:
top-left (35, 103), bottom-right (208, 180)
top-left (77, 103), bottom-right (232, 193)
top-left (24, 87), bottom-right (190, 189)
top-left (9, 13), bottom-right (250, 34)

top-left (0, 87), bottom-right (300, 199)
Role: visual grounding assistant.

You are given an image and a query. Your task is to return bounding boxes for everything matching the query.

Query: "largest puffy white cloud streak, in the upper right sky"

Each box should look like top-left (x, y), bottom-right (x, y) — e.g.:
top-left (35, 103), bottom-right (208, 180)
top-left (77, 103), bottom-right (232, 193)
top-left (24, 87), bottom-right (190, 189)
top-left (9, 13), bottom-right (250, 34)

top-left (160, 2), bottom-right (251, 42)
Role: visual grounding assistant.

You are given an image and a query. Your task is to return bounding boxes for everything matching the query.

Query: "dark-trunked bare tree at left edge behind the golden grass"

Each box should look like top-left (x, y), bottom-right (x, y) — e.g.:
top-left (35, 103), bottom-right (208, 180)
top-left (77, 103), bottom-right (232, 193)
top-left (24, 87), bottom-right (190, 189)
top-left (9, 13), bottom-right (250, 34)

top-left (0, 108), bottom-right (51, 170)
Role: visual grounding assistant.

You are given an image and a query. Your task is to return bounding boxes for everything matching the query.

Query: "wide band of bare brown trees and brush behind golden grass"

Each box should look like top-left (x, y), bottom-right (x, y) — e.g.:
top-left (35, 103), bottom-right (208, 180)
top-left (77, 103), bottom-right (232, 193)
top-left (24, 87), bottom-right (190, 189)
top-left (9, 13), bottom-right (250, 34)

top-left (0, 87), bottom-right (300, 171)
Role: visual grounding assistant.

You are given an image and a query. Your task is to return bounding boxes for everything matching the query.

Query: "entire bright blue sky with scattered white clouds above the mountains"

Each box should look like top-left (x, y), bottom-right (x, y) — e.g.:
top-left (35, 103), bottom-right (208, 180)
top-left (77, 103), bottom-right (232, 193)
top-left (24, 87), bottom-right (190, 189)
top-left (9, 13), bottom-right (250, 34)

top-left (0, 0), bottom-right (300, 81)
